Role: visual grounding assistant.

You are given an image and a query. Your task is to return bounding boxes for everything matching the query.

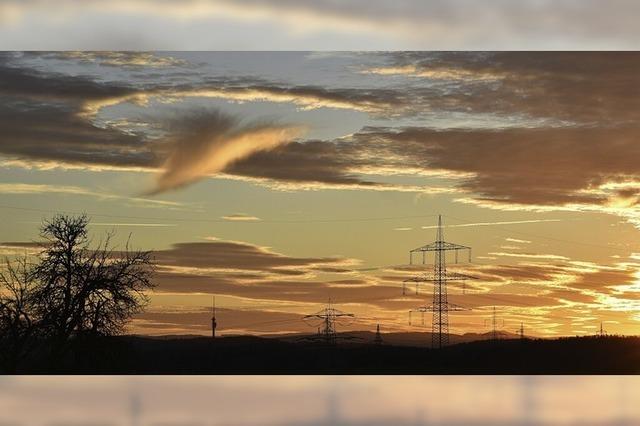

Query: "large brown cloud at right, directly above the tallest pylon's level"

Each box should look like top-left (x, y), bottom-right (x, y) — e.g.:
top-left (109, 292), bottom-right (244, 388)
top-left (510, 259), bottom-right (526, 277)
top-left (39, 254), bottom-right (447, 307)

top-left (372, 127), bottom-right (640, 213)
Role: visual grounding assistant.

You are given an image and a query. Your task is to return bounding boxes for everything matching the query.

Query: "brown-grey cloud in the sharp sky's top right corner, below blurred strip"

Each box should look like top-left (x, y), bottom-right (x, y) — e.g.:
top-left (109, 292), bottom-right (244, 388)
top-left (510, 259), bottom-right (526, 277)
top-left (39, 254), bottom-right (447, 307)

top-left (368, 52), bottom-right (640, 127)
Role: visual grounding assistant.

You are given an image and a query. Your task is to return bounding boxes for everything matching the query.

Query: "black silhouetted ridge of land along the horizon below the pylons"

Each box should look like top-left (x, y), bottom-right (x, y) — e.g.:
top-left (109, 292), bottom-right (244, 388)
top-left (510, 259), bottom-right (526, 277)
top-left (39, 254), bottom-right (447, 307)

top-left (12, 335), bottom-right (640, 374)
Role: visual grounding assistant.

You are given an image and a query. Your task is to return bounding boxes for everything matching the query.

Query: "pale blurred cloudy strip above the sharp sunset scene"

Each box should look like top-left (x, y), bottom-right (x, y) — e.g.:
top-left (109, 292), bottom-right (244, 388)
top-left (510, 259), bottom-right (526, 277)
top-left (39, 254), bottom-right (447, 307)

top-left (6, 0), bottom-right (639, 50)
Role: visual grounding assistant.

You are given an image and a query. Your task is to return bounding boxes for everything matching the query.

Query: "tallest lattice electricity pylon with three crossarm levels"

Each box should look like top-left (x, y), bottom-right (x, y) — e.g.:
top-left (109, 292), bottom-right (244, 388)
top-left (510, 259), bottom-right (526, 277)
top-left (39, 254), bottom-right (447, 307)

top-left (402, 215), bottom-right (474, 349)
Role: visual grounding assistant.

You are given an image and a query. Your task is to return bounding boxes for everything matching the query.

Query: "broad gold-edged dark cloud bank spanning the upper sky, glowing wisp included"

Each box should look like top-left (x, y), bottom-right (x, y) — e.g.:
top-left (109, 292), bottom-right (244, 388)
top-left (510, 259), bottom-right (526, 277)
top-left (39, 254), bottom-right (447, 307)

top-left (0, 52), bottom-right (640, 211)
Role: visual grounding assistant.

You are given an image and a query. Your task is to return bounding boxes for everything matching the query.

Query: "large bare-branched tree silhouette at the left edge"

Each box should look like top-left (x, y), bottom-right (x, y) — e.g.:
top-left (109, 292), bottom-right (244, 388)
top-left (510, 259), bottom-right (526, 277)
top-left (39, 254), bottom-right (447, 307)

top-left (0, 215), bottom-right (154, 372)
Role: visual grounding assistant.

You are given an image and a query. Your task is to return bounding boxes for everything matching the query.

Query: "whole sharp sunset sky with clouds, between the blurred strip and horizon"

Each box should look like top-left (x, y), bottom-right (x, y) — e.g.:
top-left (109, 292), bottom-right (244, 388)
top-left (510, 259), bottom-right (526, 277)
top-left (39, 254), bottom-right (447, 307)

top-left (0, 51), bottom-right (640, 337)
